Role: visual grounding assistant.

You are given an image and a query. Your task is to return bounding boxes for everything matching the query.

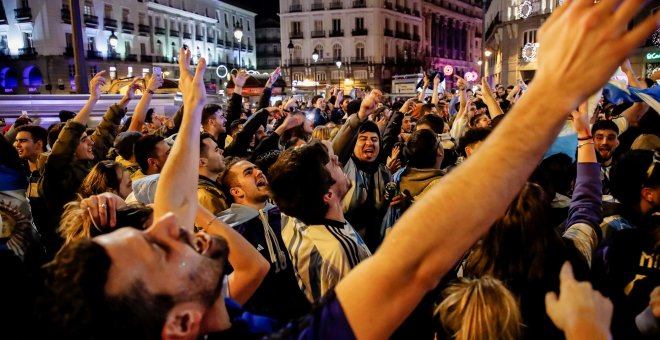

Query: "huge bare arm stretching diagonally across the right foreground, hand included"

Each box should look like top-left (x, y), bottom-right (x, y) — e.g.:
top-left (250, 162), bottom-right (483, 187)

top-left (336, 0), bottom-right (660, 339)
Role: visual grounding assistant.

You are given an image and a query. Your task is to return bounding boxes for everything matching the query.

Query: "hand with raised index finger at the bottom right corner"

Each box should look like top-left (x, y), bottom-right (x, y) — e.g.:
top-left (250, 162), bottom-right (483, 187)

top-left (545, 262), bottom-right (613, 338)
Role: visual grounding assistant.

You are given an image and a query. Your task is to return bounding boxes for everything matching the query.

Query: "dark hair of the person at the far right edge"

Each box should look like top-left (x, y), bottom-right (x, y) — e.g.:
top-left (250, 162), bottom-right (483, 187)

top-left (610, 150), bottom-right (660, 207)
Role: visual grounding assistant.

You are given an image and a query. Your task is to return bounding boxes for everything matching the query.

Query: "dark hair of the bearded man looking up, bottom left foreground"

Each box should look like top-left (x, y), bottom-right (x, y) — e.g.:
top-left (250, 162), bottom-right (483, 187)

top-left (37, 239), bottom-right (175, 339)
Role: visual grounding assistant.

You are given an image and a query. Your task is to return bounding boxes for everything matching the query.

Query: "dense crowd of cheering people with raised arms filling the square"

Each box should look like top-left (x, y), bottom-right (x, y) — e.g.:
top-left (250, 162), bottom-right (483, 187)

top-left (0, 0), bottom-right (660, 339)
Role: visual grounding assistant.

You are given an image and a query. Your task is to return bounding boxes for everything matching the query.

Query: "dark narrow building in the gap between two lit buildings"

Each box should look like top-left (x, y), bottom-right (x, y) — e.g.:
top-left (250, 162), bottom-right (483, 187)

top-left (256, 17), bottom-right (282, 73)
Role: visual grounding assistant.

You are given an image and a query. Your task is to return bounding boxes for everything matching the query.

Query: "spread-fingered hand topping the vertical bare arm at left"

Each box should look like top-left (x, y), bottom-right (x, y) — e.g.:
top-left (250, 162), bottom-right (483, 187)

top-left (179, 48), bottom-right (206, 107)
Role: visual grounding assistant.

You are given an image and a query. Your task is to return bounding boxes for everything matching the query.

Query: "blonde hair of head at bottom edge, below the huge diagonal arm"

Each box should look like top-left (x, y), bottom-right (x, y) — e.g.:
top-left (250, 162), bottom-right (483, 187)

top-left (435, 276), bottom-right (522, 340)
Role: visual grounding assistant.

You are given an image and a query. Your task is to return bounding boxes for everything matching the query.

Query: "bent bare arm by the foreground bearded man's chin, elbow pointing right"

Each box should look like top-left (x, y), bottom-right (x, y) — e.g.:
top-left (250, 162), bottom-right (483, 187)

top-left (195, 206), bottom-right (270, 305)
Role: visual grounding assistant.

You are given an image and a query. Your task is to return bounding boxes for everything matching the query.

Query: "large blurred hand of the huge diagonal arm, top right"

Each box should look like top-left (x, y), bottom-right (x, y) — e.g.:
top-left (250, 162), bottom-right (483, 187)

top-left (534, 0), bottom-right (660, 110)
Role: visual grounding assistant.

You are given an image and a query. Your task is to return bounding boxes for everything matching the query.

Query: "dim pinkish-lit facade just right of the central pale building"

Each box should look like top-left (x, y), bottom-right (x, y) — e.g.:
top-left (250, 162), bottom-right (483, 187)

top-left (422, 0), bottom-right (484, 80)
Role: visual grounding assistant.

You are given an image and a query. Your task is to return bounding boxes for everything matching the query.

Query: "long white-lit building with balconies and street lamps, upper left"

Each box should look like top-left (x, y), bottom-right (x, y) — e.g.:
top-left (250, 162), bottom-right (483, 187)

top-left (0, 0), bottom-right (257, 93)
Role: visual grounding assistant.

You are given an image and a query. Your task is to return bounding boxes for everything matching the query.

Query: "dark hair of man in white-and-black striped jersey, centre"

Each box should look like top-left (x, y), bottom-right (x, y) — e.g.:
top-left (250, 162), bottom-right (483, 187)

top-left (268, 141), bottom-right (335, 225)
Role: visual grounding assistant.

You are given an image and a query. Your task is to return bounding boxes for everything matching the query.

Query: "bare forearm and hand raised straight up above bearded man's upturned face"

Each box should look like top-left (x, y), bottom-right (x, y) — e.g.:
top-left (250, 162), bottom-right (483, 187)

top-left (154, 48), bottom-right (206, 229)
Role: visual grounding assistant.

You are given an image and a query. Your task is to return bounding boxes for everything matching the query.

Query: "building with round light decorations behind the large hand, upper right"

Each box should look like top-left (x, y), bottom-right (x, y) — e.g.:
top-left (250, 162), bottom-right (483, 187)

top-left (483, 0), bottom-right (660, 85)
